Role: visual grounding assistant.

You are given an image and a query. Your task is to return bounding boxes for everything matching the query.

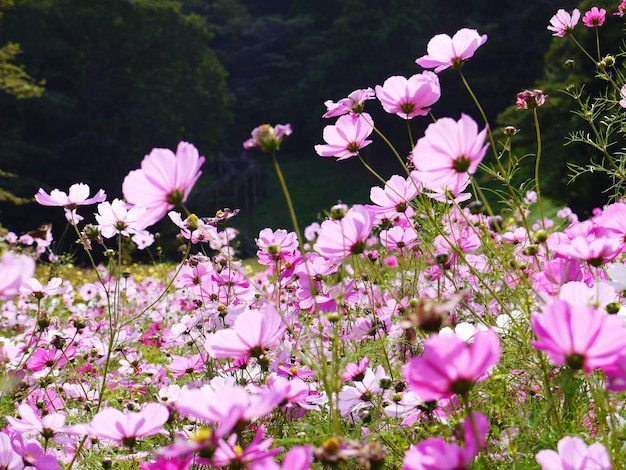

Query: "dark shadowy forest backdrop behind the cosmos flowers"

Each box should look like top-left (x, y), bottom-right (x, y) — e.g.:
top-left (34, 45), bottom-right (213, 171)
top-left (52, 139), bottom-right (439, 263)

top-left (0, 0), bottom-right (608, 255)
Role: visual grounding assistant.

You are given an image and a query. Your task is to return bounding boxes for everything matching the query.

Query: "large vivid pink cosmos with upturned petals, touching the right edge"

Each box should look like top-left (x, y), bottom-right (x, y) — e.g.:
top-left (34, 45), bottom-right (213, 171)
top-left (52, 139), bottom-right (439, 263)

top-left (530, 300), bottom-right (626, 375)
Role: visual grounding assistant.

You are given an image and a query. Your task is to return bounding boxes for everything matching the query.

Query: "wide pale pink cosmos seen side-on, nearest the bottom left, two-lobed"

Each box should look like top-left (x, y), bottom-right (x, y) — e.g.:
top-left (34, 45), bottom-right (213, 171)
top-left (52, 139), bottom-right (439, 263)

top-left (89, 403), bottom-right (170, 448)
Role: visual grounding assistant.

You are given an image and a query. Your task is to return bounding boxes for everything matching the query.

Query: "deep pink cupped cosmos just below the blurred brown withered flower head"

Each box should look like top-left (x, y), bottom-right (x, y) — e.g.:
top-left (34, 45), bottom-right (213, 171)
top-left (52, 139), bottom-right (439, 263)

top-left (402, 330), bottom-right (500, 401)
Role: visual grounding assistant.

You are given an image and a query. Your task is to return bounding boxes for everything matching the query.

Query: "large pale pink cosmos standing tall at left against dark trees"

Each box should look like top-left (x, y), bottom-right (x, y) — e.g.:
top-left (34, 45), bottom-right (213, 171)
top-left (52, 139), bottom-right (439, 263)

top-left (122, 142), bottom-right (204, 227)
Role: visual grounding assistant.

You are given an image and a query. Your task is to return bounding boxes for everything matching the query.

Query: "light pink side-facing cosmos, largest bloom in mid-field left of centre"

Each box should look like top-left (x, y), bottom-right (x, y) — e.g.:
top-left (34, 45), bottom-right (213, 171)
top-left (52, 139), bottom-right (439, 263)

top-left (204, 305), bottom-right (286, 359)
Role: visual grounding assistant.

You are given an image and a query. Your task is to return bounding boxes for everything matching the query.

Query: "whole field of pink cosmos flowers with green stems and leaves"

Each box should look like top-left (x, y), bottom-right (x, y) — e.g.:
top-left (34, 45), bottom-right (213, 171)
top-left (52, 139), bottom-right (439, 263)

top-left (0, 1), bottom-right (626, 470)
